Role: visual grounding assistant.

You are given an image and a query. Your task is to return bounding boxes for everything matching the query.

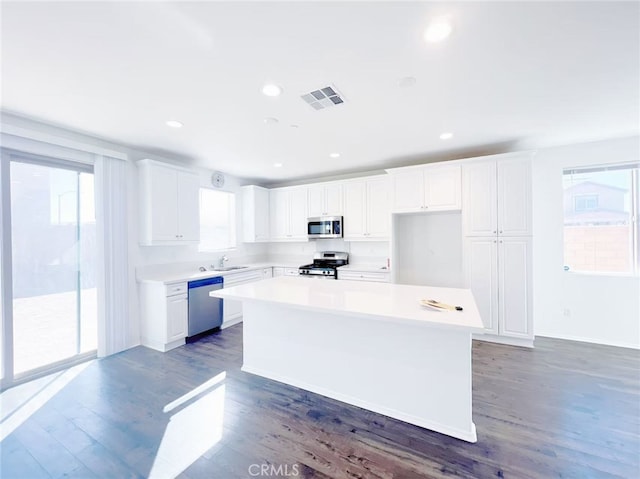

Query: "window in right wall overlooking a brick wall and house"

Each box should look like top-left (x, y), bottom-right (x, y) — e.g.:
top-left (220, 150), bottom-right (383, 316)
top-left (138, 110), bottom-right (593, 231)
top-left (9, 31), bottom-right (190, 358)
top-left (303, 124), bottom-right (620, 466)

top-left (563, 164), bottom-right (639, 274)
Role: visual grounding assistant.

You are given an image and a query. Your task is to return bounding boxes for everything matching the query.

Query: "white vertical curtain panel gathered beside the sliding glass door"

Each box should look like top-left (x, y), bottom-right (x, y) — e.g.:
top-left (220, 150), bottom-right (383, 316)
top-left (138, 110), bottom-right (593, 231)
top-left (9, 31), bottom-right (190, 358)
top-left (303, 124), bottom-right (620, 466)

top-left (94, 155), bottom-right (132, 356)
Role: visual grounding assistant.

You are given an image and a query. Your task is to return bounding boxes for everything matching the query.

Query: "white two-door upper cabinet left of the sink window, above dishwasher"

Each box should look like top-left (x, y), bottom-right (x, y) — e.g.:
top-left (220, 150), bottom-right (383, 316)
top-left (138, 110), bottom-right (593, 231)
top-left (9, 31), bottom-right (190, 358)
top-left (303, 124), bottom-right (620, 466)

top-left (138, 160), bottom-right (200, 245)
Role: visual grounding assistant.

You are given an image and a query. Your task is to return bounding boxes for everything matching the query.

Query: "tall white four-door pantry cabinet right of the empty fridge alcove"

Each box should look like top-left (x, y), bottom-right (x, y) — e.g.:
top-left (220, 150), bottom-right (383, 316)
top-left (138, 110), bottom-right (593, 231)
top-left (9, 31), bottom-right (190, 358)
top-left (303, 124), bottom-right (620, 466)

top-left (462, 153), bottom-right (533, 346)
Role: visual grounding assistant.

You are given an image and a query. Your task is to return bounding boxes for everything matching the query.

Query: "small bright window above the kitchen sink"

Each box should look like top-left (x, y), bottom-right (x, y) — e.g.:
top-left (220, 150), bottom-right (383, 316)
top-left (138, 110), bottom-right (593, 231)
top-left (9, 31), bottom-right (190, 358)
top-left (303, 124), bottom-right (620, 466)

top-left (200, 188), bottom-right (236, 251)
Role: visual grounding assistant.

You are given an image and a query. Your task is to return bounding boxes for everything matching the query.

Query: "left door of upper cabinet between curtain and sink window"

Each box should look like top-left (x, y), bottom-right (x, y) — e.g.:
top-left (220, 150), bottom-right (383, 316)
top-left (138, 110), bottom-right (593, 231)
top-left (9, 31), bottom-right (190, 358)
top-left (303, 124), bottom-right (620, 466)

top-left (146, 166), bottom-right (180, 241)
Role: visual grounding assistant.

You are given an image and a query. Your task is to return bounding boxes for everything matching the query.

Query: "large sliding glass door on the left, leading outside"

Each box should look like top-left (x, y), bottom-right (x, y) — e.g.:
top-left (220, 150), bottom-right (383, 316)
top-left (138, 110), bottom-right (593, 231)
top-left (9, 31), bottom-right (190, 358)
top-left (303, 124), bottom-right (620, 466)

top-left (2, 152), bottom-right (97, 388)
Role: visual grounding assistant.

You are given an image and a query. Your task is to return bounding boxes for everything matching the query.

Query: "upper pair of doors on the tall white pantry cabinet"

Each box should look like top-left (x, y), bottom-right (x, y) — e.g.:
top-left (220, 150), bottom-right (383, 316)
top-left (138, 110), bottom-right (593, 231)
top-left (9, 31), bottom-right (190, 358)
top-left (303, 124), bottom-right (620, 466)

top-left (463, 154), bottom-right (531, 236)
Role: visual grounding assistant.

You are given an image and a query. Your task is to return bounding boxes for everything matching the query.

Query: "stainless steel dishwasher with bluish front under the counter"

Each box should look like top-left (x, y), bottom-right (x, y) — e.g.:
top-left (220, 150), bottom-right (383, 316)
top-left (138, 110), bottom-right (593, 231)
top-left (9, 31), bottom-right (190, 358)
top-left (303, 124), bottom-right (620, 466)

top-left (187, 276), bottom-right (224, 338)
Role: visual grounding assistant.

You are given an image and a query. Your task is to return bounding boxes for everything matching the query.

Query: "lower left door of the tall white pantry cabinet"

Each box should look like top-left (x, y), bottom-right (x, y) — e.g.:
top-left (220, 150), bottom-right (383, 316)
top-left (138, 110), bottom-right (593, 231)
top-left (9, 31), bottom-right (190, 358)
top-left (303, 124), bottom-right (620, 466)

top-left (465, 238), bottom-right (498, 334)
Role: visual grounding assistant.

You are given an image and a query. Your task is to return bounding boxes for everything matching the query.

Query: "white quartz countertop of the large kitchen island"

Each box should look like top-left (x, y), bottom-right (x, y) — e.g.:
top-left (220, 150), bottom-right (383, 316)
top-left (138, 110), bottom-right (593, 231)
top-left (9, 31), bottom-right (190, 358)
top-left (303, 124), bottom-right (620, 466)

top-left (210, 276), bottom-right (484, 331)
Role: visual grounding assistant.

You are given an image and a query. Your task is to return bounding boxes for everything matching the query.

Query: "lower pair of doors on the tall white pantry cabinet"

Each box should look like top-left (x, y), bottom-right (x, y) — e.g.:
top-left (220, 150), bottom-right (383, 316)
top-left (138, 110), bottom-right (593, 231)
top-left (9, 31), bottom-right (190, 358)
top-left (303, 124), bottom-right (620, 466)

top-left (465, 237), bottom-right (533, 345)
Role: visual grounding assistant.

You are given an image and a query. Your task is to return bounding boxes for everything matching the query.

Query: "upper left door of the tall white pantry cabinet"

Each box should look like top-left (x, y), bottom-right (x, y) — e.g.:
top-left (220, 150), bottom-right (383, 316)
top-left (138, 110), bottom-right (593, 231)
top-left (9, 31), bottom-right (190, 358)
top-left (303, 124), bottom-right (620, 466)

top-left (462, 162), bottom-right (498, 236)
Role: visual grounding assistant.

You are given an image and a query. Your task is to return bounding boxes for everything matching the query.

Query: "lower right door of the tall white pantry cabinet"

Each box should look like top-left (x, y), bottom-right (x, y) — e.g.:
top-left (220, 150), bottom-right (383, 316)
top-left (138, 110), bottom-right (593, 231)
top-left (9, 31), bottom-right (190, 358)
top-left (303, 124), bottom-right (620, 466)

top-left (498, 237), bottom-right (533, 339)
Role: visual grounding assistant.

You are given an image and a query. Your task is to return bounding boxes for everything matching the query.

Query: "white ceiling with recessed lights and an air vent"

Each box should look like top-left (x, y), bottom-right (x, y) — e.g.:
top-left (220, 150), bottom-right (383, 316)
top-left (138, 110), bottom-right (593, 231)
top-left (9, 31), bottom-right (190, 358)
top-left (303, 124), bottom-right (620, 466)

top-left (1, 2), bottom-right (640, 182)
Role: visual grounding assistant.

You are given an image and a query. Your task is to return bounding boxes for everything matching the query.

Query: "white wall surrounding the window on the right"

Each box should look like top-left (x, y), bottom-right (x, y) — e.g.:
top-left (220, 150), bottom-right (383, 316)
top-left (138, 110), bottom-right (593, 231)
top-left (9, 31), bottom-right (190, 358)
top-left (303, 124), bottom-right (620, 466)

top-left (533, 137), bottom-right (640, 348)
